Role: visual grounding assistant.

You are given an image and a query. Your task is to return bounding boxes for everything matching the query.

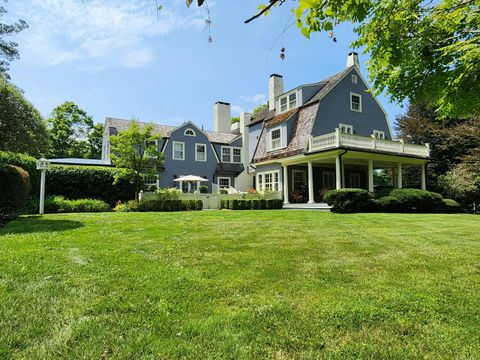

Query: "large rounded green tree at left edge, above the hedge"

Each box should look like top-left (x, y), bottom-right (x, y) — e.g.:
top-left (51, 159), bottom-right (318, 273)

top-left (0, 75), bottom-right (48, 157)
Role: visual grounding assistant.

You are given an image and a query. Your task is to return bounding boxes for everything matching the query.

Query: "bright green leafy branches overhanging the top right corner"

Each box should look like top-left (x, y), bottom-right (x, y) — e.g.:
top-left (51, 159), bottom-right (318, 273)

top-left (187, 0), bottom-right (480, 118)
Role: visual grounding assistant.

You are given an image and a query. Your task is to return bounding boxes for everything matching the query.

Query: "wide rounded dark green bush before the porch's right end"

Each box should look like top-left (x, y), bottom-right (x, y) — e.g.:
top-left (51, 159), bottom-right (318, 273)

top-left (389, 189), bottom-right (443, 213)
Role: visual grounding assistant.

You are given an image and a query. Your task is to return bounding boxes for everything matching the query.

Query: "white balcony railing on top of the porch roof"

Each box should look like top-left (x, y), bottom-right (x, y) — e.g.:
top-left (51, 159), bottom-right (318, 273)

top-left (309, 129), bottom-right (430, 157)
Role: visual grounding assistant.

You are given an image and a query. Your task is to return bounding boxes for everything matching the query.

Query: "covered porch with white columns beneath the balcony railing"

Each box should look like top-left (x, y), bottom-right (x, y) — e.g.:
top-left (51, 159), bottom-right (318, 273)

top-left (281, 149), bottom-right (428, 204)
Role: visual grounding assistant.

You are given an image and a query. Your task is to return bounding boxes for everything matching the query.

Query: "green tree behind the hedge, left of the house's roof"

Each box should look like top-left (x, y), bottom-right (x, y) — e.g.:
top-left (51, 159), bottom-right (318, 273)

top-left (47, 101), bottom-right (93, 158)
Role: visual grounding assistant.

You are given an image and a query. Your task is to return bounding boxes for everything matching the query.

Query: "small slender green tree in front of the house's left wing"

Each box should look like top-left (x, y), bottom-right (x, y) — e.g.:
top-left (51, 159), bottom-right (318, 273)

top-left (110, 121), bottom-right (163, 201)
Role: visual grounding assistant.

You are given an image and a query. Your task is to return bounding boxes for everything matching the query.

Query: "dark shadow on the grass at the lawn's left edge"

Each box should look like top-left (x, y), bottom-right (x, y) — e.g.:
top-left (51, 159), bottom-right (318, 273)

top-left (0, 216), bottom-right (84, 236)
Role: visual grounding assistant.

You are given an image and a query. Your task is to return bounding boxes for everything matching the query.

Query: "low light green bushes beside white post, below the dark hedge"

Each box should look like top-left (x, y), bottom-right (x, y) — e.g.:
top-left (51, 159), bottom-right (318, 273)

top-left (45, 196), bottom-right (110, 214)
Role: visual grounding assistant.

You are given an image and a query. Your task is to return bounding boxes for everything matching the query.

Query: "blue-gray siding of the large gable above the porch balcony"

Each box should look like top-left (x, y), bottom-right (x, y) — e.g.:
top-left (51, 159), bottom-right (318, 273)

top-left (312, 69), bottom-right (392, 139)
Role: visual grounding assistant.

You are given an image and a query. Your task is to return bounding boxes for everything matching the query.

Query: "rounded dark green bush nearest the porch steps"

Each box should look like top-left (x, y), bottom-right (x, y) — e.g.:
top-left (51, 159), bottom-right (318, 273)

top-left (323, 189), bottom-right (376, 213)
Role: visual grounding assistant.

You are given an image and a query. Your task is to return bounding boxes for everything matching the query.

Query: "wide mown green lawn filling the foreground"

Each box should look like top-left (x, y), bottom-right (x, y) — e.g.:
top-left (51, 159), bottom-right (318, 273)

top-left (0, 211), bottom-right (480, 359)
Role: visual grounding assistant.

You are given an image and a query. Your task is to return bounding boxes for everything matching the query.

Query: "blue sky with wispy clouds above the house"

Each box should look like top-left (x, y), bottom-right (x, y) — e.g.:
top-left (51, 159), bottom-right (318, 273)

top-left (6, 0), bottom-right (404, 129)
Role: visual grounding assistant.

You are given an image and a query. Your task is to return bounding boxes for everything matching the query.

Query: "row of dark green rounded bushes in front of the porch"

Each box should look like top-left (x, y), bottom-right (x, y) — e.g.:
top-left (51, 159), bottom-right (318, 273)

top-left (324, 189), bottom-right (461, 213)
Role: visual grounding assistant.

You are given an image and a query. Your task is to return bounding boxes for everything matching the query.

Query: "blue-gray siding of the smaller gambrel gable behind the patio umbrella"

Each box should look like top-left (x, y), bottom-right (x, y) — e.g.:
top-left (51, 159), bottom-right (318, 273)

top-left (160, 123), bottom-right (217, 191)
